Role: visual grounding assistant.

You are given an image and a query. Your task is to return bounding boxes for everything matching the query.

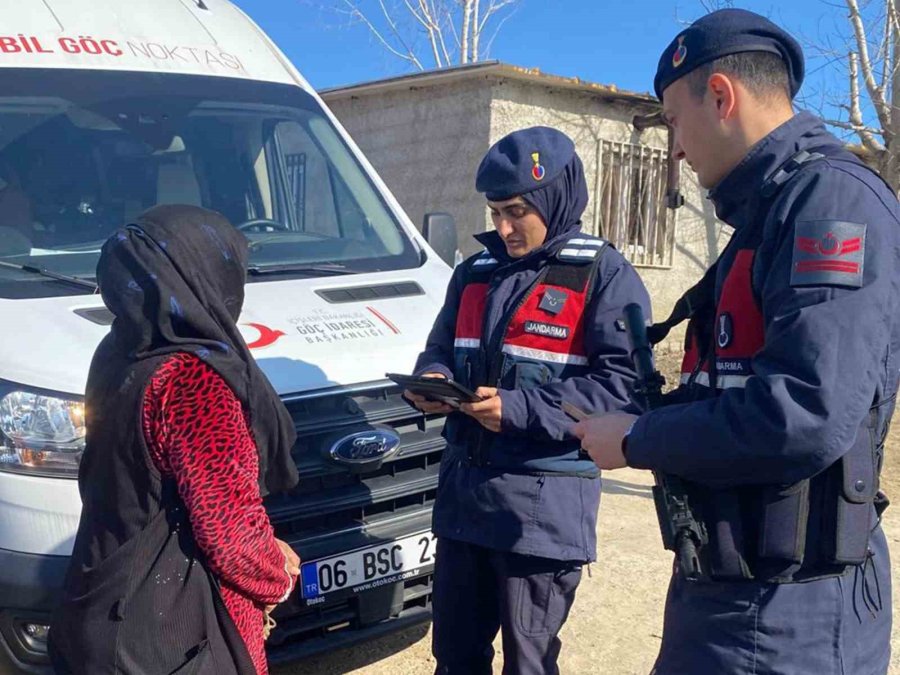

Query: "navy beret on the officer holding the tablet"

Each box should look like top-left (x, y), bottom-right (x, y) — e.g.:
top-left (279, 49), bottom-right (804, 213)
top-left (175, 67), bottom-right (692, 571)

top-left (475, 127), bottom-right (575, 201)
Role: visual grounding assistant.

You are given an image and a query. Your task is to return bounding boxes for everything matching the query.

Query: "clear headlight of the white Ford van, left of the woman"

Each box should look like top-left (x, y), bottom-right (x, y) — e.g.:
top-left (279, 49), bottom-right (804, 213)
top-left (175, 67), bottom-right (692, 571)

top-left (0, 390), bottom-right (84, 478)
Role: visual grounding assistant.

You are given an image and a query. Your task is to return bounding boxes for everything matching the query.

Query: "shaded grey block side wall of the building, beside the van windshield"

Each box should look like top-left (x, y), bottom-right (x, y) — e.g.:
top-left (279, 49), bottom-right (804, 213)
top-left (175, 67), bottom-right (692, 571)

top-left (324, 80), bottom-right (491, 252)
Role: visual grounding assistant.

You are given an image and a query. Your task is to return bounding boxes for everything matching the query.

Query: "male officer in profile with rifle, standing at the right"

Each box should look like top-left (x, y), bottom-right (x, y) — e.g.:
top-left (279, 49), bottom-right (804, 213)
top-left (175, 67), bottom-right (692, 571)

top-left (576, 9), bottom-right (900, 675)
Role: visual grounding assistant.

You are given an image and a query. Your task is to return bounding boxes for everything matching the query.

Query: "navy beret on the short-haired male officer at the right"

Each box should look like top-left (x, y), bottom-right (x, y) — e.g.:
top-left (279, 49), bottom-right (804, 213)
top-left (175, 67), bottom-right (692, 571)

top-left (653, 9), bottom-right (804, 101)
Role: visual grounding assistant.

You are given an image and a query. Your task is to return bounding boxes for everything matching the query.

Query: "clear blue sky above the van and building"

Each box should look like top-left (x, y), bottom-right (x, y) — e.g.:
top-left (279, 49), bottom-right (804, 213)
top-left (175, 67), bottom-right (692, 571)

top-left (236, 0), bottom-right (878, 138)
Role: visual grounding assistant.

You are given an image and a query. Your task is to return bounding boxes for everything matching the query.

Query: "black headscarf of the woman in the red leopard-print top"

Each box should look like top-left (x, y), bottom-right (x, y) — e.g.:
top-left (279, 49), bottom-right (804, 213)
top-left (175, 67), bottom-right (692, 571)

top-left (97, 205), bottom-right (298, 495)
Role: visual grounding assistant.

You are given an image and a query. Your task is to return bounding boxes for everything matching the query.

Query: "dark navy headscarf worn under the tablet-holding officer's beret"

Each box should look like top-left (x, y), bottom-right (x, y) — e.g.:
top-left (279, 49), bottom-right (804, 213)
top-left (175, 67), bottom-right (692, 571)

top-left (522, 154), bottom-right (588, 246)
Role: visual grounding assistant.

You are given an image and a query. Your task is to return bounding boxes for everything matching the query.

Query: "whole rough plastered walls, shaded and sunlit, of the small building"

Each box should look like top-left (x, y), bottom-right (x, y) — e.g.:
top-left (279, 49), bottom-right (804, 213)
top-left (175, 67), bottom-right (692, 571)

top-left (325, 77), bottom-right (728, 350)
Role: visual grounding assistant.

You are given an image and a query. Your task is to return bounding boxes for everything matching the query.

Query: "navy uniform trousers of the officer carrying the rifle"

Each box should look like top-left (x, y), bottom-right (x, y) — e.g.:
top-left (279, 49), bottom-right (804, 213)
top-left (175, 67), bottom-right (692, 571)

top-left (652, 527), bottom-right (891, 675)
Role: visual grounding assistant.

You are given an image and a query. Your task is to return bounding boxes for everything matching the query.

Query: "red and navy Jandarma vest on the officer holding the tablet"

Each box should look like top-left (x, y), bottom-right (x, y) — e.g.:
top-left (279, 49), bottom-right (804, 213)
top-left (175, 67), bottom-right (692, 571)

top-left (447, 235), bottom-right (607, 477)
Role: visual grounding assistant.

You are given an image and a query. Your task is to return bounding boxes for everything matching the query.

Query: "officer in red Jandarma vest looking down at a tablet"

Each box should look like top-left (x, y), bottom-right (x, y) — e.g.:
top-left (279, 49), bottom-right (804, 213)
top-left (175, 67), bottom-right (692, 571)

top-left (407, 127), bottom-right (649, 675)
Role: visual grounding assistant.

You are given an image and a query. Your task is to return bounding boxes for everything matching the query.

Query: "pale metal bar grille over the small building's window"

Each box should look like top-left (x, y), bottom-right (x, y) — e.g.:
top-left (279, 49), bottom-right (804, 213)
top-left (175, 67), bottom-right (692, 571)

top-left (593, 139), bottom-right (676, 267)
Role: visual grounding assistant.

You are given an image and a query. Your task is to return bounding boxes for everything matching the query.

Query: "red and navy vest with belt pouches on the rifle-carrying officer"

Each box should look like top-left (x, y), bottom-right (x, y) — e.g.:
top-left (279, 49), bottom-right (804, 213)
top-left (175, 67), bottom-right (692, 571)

top-left (648, 153), bottom-right (894, 582)
